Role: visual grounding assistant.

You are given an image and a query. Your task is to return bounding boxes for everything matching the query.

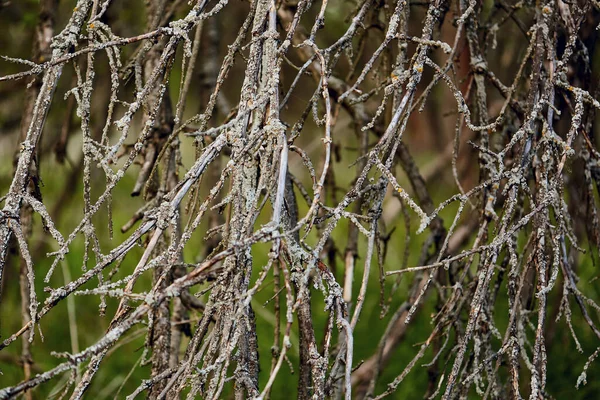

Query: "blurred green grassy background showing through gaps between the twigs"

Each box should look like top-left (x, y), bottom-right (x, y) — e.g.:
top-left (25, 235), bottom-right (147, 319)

top-left (0, 0), bottom-right (600, 399)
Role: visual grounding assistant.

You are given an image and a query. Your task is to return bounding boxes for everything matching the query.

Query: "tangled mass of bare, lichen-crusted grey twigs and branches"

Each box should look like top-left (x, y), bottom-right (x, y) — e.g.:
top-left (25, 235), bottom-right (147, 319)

top-left (0, 0), bottom-right (600, 399)
